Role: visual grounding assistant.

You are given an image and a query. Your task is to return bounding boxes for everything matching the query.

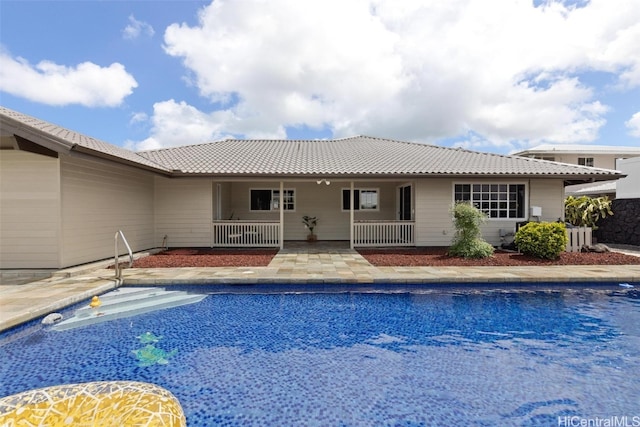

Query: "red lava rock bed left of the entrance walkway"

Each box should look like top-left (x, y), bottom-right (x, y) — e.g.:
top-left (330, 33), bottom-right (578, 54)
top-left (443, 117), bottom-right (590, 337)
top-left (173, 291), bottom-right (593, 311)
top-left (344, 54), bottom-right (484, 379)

top-left (133, 249), bottom-right (278, 268)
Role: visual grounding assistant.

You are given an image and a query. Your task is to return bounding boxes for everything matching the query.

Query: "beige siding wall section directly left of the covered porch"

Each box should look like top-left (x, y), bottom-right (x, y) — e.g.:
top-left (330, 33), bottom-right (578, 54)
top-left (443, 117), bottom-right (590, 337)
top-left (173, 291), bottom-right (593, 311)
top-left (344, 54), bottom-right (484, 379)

top-left (155, 177), bottom-right (214, 247)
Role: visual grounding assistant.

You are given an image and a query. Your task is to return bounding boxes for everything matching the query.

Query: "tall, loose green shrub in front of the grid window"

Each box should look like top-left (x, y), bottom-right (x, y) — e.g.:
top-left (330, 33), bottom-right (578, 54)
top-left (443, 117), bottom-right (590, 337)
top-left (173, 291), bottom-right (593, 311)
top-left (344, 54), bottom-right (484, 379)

top-left (448, 202), bottom-right (493, 258)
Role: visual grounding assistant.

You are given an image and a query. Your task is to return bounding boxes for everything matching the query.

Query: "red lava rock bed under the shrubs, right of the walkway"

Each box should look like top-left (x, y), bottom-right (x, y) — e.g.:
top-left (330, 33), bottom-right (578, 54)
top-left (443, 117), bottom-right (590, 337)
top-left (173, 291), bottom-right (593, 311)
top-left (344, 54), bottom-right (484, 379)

top-left (358, 248), bottom-right (640, 267)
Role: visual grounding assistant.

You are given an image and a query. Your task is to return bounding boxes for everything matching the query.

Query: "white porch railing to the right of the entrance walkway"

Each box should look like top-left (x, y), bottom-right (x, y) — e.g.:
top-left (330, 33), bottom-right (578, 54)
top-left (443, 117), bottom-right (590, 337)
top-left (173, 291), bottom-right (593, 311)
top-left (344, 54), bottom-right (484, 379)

top-left (353, 221), bottom-right (415, 246)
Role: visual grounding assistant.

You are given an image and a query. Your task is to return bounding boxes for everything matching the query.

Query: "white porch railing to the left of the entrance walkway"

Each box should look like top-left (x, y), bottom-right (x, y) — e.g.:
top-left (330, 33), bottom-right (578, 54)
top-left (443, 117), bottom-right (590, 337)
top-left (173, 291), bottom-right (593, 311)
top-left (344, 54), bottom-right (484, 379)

top-left (212, 221), bottom-right (280, 248)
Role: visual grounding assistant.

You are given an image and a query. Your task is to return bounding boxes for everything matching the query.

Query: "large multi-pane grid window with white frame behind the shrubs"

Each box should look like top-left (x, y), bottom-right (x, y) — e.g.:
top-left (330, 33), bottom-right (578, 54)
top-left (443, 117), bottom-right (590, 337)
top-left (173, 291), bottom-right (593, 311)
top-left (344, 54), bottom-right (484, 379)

top-left (454, 184), bottom-right (525, 219)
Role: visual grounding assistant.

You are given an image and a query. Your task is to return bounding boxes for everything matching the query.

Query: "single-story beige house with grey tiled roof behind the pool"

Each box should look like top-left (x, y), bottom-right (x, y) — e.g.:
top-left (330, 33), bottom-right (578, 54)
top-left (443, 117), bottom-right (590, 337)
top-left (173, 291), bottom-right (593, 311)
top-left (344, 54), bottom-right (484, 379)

top-left (0, 107), bottom-right (623, 269)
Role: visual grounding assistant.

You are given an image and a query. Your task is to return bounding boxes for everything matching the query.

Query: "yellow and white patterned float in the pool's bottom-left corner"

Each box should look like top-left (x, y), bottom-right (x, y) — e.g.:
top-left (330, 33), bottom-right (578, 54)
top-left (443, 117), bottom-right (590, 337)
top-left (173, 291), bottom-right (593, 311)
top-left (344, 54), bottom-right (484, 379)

top-left (0, 381), bottom-right (187, 427)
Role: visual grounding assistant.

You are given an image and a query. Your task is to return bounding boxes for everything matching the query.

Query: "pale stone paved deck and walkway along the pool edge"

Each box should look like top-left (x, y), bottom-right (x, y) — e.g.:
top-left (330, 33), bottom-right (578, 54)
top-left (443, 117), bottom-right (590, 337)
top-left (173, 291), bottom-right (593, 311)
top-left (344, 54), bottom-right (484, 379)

top-left (0, 246), bottom-right (640, 331)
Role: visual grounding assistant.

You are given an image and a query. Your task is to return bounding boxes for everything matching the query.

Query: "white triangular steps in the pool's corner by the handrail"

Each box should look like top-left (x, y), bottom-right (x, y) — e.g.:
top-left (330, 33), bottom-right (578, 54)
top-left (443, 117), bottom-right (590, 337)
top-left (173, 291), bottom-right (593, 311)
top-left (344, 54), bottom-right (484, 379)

top-left (52, 288), bottom-right (206, 331)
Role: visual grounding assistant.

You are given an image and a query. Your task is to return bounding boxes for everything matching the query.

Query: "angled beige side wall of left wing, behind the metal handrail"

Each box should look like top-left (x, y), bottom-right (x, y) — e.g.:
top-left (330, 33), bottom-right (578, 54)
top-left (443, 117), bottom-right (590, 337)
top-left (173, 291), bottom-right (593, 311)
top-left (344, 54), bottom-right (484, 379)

top-left (61, 156), bottom-right (154, 266)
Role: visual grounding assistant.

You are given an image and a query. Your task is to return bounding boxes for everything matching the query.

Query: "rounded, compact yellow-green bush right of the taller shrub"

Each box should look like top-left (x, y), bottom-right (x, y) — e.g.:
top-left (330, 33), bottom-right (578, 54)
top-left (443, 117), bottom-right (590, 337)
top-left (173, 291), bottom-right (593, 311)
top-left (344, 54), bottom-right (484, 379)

top-left (514, 222), bottom-right (569, 259)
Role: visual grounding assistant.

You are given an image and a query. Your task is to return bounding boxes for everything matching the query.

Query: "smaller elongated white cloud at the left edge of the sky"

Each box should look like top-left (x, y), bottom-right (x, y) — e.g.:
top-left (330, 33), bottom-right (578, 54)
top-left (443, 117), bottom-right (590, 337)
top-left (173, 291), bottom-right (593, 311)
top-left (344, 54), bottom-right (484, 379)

top-left (0, 52), bottom-right (138, 107)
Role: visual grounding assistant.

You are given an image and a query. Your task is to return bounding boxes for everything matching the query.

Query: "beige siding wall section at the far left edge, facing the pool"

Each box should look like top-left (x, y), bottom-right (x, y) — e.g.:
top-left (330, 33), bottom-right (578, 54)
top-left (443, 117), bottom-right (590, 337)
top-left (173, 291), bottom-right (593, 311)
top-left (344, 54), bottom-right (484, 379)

top-left (0, 150), bottom-right (60, 268)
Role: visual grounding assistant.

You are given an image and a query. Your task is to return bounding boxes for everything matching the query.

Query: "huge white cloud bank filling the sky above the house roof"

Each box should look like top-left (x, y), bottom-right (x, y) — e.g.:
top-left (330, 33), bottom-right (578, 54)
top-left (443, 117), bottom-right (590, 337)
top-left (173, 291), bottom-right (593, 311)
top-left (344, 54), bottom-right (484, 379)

top-left (141, 0), bottom-right (640, 150)
